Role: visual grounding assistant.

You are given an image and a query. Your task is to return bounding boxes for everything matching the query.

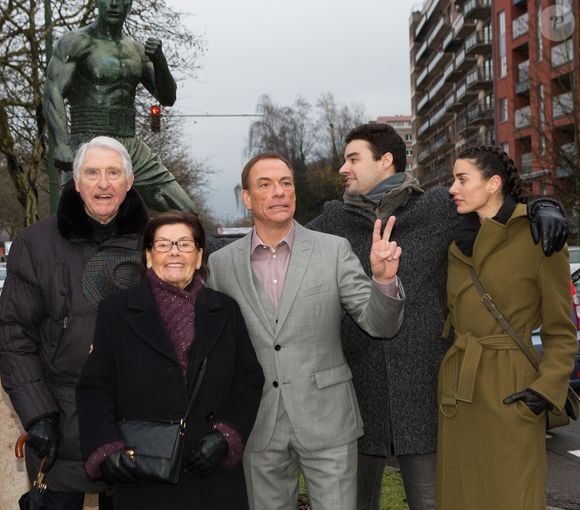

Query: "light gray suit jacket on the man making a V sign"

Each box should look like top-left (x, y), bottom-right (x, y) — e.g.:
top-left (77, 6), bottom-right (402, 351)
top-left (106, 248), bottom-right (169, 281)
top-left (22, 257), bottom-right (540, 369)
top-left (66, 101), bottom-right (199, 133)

top-left (207, 223), bottom-right (404, 451)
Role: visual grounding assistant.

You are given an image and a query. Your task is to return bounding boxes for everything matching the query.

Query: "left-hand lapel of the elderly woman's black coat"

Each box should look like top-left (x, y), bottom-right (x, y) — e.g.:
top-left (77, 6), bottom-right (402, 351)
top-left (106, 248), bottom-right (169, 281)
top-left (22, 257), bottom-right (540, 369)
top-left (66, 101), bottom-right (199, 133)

top-left (126, 278), bottom-right (178, 363)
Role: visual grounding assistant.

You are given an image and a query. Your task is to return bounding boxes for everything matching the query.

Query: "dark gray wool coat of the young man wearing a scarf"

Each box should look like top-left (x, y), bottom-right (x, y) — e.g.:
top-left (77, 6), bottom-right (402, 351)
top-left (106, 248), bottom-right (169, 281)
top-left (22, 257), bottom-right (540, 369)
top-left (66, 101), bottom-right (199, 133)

top-left (307, 187), bottom-right (459, 456)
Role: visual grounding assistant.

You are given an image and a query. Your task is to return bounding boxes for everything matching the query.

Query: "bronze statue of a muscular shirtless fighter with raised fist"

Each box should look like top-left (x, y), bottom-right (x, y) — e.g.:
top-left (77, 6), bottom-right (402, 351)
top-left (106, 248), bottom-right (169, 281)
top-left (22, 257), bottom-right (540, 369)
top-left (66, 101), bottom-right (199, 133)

top-left (44, 0), bottom-right (194, 211)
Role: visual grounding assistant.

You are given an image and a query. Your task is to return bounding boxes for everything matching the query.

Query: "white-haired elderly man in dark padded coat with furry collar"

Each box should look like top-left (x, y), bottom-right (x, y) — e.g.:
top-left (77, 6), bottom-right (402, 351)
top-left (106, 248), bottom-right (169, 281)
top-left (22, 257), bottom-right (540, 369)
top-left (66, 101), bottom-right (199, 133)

top-left (0, 136), bottom-right (148, 510)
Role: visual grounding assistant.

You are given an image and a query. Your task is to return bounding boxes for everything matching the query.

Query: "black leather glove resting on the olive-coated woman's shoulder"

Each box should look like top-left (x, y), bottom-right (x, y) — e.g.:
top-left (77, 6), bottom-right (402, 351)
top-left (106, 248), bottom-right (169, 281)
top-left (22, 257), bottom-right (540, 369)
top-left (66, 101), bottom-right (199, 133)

top-left (528, 198), bottom-right (569, 257)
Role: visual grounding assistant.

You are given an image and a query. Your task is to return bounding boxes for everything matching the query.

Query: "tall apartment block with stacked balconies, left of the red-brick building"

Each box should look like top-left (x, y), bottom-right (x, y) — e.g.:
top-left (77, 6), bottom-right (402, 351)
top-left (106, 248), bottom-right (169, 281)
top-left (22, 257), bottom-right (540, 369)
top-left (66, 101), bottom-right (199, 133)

top-left (410, 0), bottom-right (495, 188)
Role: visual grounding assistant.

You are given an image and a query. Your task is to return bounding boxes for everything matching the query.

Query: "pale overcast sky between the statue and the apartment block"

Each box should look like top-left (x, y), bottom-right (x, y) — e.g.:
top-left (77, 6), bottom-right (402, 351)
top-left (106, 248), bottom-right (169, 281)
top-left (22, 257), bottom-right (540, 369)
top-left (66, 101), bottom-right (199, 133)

top-left (167, 0), bottom-right (421, 220)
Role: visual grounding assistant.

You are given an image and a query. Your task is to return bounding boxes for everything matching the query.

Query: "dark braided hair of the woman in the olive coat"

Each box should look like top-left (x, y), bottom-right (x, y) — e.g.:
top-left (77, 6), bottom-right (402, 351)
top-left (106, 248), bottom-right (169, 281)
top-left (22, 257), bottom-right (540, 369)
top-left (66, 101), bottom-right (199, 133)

top-left (457, 145), bottom-right (528, 204)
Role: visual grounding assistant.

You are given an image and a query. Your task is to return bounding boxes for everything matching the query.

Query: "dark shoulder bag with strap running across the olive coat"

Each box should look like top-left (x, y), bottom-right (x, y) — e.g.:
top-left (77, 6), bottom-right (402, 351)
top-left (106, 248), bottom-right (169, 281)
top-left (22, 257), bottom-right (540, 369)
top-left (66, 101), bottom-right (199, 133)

top-left (471, 268), bottom-right (578, 430)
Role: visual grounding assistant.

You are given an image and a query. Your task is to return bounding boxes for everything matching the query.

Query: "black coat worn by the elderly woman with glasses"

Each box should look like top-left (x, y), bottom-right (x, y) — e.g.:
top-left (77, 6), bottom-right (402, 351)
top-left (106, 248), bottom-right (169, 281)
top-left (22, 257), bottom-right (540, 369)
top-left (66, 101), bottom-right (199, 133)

top-left (77, 279), bottom-right (264, 510)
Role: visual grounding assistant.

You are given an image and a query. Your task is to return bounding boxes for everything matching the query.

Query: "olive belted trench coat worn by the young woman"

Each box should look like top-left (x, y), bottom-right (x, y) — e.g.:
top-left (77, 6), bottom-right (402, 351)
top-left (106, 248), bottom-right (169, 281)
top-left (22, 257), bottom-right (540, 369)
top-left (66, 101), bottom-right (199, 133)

top-left (437, 204), bottom-right (577, 510)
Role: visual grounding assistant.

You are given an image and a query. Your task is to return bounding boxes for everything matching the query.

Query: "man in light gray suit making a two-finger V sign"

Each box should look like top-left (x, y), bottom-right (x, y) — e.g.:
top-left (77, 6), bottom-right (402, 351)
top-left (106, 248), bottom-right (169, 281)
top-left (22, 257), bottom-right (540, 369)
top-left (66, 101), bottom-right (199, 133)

top-left (207, 153), bottom-right (404, 510)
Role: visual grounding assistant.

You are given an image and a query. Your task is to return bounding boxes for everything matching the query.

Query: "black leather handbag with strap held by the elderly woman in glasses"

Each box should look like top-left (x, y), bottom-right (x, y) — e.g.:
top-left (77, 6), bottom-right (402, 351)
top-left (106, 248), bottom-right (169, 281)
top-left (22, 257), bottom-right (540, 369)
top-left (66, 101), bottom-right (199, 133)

top-left (117, 358), bottom-right (207, 484)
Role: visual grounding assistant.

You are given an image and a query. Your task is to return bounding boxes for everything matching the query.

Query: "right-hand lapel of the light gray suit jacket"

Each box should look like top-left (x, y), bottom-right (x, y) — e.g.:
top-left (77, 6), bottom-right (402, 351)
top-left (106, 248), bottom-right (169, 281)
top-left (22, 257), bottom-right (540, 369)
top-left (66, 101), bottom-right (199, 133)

top-left (276, 223), bottom-right (314, 335)
